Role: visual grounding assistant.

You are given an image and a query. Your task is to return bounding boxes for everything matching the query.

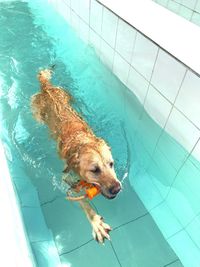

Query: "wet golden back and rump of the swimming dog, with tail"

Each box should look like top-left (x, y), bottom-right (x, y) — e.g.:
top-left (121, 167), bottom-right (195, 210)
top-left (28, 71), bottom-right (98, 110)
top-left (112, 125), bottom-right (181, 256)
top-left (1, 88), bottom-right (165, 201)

top-left (31, 70), bottom-right (92, 157)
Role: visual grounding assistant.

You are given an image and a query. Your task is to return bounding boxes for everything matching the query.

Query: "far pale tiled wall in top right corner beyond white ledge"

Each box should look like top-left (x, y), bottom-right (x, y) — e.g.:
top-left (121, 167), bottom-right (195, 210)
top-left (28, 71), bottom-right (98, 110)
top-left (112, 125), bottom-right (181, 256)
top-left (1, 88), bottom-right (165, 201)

top-left (153, 0), bottom-right (200, 26)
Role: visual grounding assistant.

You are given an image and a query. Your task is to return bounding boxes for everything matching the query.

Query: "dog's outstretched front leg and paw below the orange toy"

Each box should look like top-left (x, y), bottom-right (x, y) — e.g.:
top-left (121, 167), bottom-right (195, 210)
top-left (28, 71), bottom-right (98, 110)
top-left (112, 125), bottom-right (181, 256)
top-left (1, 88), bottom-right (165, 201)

top-left (79, 199), bottom-right (111, 243)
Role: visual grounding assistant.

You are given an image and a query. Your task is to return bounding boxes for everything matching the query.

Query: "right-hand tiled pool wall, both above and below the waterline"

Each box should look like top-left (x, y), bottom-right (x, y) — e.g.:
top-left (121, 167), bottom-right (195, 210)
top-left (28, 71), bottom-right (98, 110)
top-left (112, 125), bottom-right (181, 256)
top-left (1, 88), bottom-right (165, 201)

top-left (49, 0), bottom-right (200, 267)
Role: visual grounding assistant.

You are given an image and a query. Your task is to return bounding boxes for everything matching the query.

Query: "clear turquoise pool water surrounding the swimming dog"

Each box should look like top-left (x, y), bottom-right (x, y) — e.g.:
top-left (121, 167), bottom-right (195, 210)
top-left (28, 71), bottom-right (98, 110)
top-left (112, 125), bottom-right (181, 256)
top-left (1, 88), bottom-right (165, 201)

top-left (0, 1), bottom-right (199, 267)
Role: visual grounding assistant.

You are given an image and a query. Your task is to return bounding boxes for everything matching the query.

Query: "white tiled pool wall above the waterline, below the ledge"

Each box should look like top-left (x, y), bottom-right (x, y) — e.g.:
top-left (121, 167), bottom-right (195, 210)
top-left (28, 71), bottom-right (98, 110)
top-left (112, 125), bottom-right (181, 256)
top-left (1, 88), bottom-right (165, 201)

top-left (48, 0), bottom-right (200, 163)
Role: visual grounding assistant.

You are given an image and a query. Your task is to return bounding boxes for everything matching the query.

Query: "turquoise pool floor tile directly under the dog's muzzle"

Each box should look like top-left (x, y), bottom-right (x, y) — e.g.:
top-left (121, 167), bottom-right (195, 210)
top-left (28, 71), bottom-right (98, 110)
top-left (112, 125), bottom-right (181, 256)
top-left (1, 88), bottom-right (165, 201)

top-left (93, 178), bottom-right (147, 228)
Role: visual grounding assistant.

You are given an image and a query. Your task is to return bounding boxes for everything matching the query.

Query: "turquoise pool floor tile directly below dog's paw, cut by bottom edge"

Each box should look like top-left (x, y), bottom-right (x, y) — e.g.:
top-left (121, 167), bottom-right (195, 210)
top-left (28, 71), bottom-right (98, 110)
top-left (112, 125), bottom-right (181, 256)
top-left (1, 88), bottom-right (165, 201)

top-left (60, 241), bottom-right (120, 267)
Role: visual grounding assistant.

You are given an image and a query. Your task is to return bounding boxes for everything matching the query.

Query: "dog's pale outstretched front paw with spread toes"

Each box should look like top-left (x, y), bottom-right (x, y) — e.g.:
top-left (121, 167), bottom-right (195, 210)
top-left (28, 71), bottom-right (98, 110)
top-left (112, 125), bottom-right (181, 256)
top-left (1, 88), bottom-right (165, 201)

top-left (91, 214), bottom-right (112, 243)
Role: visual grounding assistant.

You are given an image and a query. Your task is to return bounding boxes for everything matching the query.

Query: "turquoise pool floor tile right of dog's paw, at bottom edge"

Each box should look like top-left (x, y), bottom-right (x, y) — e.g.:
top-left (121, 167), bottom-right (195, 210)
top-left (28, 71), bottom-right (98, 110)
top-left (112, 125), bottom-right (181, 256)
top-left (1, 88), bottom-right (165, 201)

top-left (111, 215), bottom-right (177, 267)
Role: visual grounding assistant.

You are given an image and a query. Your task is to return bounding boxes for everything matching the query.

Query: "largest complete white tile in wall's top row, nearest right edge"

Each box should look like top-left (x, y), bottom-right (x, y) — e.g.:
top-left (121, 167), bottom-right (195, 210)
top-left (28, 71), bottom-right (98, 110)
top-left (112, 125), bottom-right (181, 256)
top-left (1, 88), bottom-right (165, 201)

top-left (151, 50), bottom-right (186, 103)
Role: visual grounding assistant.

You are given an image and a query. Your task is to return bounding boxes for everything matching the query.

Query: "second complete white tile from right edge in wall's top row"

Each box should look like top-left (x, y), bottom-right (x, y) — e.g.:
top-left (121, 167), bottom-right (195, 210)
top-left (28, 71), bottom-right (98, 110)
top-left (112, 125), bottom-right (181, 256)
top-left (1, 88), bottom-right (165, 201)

top-left (132, 33), bottom-right (158, 80)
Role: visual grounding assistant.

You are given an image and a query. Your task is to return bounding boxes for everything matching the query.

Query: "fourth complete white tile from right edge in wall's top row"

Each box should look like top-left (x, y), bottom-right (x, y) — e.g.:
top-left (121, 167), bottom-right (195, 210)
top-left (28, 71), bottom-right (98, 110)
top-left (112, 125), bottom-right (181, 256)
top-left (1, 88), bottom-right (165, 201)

top-left (102, 8), bottom-right (118, 48)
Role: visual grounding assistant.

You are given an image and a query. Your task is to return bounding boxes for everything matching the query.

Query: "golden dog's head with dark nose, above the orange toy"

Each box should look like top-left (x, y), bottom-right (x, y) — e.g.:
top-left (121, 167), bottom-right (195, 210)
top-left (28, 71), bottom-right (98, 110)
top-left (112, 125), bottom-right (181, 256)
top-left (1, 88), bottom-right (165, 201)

top-left (69, 139), bottom-right (121, 199)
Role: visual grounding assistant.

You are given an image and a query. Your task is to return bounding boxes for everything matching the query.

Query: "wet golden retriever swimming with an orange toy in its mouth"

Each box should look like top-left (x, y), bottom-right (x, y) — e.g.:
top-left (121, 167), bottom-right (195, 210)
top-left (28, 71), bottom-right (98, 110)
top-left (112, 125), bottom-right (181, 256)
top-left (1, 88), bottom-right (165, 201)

top-left (31, 69), bottom-right (121, 243)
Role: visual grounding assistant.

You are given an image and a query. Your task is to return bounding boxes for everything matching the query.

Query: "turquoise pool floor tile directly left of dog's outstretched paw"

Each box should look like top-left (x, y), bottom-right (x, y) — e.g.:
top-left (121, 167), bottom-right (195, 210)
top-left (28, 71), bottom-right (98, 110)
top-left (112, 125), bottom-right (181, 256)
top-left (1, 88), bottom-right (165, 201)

top-left (42, 196), bottom-right (92, 253)
